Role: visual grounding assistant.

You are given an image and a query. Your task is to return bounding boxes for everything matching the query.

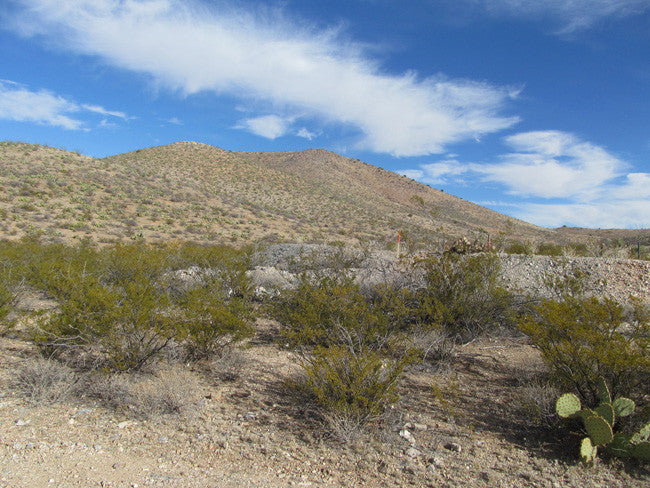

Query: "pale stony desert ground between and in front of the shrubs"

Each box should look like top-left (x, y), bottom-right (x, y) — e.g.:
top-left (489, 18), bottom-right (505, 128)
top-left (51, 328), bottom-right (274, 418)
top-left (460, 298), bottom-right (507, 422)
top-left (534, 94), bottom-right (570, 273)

top-left (0, 250), bottom-right (650, 488)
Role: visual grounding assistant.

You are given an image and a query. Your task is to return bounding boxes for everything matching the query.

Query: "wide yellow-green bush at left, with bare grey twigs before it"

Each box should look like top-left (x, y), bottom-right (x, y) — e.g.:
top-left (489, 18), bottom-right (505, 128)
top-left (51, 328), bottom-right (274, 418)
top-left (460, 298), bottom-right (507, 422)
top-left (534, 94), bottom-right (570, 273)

top-left (32, 275), bottom-right (180, 370)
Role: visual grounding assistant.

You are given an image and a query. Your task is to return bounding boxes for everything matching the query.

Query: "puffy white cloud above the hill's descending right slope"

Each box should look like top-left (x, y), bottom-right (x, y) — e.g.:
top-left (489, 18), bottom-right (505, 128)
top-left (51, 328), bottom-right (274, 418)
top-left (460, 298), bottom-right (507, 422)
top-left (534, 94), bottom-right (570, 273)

top-left (402, 131), bottom-right (650, 227)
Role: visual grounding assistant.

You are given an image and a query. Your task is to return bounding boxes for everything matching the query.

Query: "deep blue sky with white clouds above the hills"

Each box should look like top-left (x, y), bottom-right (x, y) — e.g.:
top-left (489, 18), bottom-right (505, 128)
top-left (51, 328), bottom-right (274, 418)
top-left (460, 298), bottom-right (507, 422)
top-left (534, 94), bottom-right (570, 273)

top-left (0, 0), bottom-right (650, 229)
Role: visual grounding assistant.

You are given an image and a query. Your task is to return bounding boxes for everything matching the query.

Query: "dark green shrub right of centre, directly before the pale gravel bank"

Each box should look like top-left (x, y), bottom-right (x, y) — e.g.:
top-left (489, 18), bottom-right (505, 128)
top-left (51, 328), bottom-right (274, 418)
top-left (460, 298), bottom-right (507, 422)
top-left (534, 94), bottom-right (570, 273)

top-left (418, 253), bottom-right (514, 339)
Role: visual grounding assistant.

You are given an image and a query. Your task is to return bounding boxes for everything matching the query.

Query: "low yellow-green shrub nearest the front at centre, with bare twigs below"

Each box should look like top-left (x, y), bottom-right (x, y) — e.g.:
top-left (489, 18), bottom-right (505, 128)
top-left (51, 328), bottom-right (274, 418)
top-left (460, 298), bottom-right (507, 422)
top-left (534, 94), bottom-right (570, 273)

top-left (299, 346), bottom-right (406, 440)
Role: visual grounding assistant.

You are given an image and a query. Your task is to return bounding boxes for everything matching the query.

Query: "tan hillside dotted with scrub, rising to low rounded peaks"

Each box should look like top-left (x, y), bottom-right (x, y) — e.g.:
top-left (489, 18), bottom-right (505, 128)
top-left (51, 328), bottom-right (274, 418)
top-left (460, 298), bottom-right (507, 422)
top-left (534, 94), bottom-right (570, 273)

top-left (0, 142), bottom-right (644, 246)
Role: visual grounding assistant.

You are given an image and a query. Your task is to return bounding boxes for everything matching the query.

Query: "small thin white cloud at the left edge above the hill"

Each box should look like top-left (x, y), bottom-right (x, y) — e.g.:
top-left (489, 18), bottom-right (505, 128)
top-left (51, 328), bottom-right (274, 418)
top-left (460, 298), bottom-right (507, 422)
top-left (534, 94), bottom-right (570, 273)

top-left (0, 81), bottom-right (83, 130)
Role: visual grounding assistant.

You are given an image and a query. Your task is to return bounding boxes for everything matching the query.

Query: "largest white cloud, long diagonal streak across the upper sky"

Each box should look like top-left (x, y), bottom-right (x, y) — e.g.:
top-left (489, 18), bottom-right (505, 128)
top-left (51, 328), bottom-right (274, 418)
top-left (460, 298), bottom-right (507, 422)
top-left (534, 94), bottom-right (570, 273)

top-left (6, 0), bottom-right (518, 156)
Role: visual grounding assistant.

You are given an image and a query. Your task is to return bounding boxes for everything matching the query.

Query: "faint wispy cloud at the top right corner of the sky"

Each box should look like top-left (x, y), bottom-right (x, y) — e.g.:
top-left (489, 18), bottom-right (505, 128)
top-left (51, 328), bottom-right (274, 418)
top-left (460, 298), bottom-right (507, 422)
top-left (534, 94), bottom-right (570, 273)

top-left (466, 0), bottom-right (650, 34)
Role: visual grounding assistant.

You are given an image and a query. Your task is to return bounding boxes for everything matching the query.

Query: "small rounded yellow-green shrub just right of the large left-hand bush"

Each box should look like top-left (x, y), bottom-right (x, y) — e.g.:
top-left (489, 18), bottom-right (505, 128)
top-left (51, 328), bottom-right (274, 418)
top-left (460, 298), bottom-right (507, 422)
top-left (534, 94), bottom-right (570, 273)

top-left (178, 278), bottom-right (254, 359)
